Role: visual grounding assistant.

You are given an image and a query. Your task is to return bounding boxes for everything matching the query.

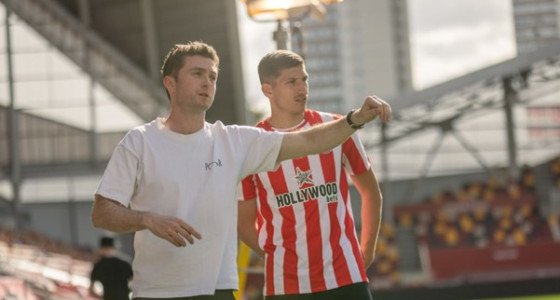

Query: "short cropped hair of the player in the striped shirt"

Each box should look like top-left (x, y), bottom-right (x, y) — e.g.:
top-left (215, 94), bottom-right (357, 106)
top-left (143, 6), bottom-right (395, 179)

top-left (258, 50), bottom-right (304, 84)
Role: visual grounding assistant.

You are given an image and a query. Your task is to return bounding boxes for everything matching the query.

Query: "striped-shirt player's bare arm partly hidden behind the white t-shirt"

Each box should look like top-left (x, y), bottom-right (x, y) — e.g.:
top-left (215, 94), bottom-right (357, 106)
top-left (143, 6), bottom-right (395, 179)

top-left (237, 198), bottom-right (264, 258)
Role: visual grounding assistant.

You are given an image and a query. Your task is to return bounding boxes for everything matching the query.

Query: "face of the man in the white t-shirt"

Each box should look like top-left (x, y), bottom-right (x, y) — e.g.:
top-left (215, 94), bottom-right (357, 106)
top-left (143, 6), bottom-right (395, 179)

top-left (166, 55), bottom-right (218, 113)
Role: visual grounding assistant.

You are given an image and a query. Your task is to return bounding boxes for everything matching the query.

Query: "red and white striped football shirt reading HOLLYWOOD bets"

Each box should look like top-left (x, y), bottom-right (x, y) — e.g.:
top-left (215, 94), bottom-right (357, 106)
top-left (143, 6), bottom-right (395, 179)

top-left (241, 110), bottom-right (370, 296)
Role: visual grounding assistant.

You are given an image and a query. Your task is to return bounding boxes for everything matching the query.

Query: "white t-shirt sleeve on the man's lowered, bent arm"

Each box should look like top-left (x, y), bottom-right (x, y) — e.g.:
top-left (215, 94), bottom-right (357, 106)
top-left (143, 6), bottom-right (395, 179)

top-left (96, 135), bottom-right (140, 206)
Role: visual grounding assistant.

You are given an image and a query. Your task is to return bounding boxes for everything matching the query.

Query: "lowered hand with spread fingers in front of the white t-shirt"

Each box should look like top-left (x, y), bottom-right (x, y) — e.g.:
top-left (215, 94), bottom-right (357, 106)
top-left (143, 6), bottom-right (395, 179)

top-left (147, 214), bottom-right (202, 247)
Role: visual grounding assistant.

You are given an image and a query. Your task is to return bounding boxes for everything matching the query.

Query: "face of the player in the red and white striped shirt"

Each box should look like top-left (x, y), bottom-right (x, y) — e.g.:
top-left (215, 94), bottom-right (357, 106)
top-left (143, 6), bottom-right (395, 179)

top-left (263, 65), bottom-right (309, 114)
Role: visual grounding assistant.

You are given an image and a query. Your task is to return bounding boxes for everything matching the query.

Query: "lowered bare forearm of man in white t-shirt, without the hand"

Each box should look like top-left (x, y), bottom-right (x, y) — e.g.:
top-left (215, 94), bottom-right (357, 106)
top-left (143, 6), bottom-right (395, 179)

top-left (91, 195), bottom-right (149, 233)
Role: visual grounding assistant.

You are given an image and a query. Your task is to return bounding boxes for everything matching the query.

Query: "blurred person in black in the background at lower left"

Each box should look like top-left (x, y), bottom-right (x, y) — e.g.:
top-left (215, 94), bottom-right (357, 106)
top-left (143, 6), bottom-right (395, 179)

top-left (89, 237), bottom-right (132, 300)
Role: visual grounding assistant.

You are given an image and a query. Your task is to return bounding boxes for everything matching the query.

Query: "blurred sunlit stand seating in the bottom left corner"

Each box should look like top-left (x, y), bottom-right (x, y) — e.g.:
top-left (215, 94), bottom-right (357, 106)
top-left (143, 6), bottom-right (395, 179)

top-left (0, 228), bottom-right (96, 300)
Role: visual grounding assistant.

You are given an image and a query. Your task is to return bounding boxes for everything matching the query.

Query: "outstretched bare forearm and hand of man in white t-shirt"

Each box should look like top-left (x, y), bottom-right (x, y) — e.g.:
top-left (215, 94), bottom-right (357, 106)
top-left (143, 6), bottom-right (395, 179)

top-left (276, 96), bottom-right (391, 163)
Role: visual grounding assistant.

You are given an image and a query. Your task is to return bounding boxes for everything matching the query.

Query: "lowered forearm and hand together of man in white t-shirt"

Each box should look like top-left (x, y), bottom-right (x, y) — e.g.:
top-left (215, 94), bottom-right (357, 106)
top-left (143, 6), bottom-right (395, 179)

top-left (91, 194), bottom-right (201, 247)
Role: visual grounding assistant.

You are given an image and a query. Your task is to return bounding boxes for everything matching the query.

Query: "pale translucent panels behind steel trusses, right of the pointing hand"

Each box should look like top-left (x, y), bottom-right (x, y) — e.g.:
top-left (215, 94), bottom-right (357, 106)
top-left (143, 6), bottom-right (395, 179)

top-left (361, 41), bottom-right (560, 178)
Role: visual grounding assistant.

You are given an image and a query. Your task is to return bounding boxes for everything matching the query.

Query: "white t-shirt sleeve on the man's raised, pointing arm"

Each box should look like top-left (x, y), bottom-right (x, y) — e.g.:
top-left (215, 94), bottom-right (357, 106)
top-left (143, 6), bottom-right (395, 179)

top-left (241, 126), bottom-right (284, 178)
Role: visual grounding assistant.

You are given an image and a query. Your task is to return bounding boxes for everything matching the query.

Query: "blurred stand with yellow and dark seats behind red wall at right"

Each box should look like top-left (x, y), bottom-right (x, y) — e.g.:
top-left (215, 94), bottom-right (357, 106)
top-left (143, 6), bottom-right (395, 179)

top-left (394, 158), bottom-right (560, 284)
